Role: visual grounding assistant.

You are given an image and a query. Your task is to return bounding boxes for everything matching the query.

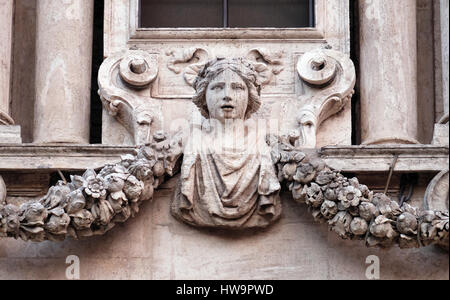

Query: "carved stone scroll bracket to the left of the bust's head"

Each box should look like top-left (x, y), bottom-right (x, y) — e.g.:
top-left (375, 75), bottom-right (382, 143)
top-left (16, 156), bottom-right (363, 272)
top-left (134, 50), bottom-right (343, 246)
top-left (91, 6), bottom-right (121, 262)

top-left (98, 50), bottom-right (158, 145)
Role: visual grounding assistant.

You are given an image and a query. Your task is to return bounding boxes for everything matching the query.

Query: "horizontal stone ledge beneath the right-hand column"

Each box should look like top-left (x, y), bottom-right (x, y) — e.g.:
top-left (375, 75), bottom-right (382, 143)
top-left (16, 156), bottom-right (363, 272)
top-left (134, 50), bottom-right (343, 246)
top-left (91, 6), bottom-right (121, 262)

top-left (319, 145), bottom-right (449, 172)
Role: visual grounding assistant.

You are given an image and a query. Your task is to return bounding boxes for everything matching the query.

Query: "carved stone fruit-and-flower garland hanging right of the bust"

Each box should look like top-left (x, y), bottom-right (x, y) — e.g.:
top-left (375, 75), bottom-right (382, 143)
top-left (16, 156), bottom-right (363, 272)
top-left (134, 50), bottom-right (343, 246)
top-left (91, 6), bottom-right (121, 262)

top-left (267, 137), bottom-right (449, 249)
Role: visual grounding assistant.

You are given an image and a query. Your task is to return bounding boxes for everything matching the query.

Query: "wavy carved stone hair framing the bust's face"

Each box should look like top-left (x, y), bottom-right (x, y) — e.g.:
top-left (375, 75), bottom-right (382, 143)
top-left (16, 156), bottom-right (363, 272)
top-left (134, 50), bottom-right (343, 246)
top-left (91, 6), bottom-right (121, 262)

top-left (192, 58), bottom-right (261, 119)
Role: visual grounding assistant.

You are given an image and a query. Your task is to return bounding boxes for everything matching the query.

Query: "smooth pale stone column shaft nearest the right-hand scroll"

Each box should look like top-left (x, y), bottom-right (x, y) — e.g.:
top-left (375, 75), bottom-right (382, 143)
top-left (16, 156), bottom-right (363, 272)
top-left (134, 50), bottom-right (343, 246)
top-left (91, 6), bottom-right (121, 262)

top-left (359, 0), bottom-right (418, 144)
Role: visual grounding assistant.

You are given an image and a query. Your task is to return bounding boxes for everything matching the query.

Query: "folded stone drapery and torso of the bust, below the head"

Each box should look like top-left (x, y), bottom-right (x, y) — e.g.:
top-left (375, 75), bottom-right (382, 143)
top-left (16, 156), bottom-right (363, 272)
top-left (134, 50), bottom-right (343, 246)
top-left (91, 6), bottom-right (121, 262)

top-left (171, 120), bottom-right (281, 229)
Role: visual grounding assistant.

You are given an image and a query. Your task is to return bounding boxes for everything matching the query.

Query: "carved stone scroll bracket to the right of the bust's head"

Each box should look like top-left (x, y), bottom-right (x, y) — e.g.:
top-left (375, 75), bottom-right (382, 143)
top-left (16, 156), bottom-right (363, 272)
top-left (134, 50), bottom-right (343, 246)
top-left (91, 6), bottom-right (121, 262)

top-left (297, 49), bottom-right (356, 148)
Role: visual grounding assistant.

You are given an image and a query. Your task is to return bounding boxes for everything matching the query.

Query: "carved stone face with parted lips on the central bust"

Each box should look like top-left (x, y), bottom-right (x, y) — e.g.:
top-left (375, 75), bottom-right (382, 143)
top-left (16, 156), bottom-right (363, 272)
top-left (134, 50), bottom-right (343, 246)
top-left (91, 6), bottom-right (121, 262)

top-left (206, 69), bottom-right (248, 123)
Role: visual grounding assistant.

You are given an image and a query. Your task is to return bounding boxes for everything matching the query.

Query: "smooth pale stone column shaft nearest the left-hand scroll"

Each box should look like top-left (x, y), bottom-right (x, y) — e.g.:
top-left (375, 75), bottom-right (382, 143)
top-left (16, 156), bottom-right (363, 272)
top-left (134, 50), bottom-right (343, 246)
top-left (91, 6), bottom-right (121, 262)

top-left (34, 0), bottom-right (93, 144)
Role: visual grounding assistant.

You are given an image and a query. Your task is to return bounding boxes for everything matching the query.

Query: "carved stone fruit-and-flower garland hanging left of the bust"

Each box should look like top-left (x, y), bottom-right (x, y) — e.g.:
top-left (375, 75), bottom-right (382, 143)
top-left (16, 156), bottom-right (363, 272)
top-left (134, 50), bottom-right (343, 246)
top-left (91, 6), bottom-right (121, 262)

top-left (0, 132), bottom-right (182, 242)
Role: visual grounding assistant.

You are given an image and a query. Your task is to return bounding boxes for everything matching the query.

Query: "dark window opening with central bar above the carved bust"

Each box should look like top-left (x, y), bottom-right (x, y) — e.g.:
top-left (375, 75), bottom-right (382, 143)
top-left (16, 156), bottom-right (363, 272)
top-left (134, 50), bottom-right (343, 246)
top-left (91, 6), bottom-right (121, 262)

top-left (139, 0), bottom-right (315, 28)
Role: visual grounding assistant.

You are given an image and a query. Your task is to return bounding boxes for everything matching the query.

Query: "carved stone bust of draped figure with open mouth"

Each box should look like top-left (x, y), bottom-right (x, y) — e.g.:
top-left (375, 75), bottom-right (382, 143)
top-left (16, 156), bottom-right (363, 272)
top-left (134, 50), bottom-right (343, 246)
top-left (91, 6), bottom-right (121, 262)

top-left (171, 58), bottom-right (281, 228)
